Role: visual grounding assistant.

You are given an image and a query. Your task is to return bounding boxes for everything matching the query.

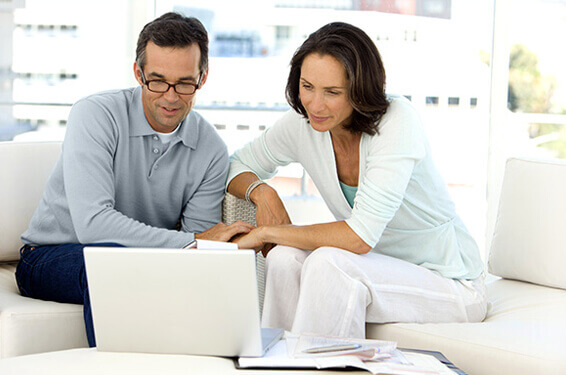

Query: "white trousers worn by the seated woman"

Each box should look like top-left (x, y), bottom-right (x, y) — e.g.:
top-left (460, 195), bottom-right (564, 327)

top-left (262, 246), bottom-right (487, 338)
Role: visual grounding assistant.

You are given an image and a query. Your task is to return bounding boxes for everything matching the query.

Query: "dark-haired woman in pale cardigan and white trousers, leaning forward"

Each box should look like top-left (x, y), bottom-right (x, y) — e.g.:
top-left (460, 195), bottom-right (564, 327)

top-left (228, 23), bottom-right (486, 338)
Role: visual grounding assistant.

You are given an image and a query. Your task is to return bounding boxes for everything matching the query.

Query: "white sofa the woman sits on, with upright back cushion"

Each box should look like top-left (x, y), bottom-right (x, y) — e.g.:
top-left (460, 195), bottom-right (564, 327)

top-left (367, 158), bottom-right (566, 375)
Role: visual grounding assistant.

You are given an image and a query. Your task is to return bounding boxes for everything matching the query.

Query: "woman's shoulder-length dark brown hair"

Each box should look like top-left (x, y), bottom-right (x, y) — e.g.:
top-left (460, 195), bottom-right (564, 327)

top-left (285, 22), bottom-right (389, 135)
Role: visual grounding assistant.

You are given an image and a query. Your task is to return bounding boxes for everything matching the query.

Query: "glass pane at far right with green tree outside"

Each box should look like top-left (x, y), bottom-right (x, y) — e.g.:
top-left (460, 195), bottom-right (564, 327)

top-left (507, 0), bottom-right (566, 158)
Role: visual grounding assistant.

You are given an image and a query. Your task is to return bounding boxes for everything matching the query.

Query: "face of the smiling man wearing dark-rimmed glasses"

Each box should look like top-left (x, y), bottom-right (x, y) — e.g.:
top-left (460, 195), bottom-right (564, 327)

top-left (134, 41), bottom-right (208, 133)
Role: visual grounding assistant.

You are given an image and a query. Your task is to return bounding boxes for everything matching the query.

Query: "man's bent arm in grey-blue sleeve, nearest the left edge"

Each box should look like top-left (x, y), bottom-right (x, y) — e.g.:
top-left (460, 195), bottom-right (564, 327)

top-left (61, 100), bottom-right (247, 248)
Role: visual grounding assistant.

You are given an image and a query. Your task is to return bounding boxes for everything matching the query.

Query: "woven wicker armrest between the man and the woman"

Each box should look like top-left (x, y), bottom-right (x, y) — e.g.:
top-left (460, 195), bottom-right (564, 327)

top-left (222, 193), bottom-right (265, 316)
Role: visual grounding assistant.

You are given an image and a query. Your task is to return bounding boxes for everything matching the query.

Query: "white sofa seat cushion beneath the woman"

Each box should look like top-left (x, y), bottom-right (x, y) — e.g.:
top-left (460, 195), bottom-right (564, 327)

top-left (367, 279), bottom-right (566, 375)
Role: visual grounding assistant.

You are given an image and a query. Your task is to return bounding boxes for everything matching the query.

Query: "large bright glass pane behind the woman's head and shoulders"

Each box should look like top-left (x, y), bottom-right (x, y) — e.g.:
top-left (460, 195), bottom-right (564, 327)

top-left (156, 0), bottom-right (493, 235)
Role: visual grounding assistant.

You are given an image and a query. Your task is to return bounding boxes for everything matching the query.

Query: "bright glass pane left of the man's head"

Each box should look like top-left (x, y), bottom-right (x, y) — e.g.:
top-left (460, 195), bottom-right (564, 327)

top-left (0, 0), bottom-right (153, 140)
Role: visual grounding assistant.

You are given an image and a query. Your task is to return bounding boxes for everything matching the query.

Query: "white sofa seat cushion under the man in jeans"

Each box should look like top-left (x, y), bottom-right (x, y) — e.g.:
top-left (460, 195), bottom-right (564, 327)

top-left (0, 263), bottom-right (88, 358)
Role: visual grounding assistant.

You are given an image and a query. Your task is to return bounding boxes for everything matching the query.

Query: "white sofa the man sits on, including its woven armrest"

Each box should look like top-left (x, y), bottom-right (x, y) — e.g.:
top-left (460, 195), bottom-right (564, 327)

top-left (0, 142), bottom-right (265, 358)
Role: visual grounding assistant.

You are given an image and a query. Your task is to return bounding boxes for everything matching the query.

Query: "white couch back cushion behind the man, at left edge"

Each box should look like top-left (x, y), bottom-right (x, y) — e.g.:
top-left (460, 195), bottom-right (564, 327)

top-left (0, 142), bottom-right (61, 261)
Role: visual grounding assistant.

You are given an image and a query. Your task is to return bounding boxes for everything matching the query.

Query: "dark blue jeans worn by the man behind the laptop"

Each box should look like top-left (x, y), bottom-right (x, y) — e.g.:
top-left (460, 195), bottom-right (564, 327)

top-left (16, 243), bottom-right (122, 347)
